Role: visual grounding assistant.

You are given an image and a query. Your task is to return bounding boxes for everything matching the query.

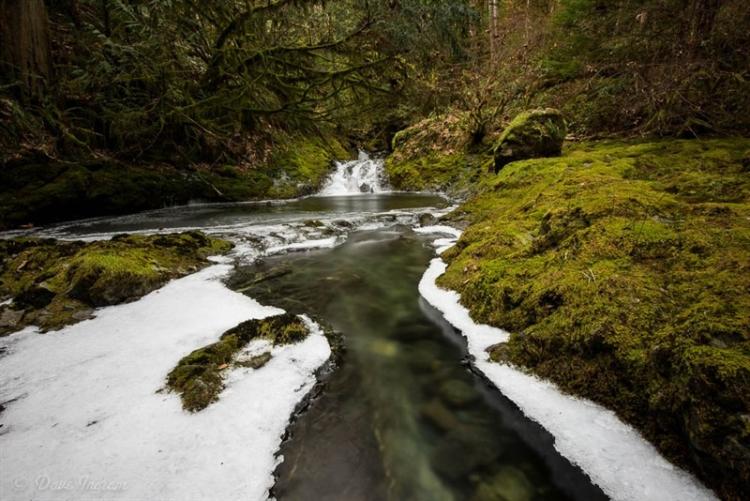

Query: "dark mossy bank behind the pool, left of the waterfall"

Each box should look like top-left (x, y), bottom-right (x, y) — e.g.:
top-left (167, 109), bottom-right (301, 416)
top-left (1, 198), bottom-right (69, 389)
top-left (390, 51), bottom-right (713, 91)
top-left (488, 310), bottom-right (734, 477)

top-left (0, 135), bottom-right (350, 230)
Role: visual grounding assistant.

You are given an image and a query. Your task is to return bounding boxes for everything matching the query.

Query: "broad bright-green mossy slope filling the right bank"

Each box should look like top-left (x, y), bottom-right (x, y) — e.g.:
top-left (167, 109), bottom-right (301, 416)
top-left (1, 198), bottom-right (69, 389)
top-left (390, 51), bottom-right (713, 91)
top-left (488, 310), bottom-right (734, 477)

top-left (440, 139), bottom-right (750, 499)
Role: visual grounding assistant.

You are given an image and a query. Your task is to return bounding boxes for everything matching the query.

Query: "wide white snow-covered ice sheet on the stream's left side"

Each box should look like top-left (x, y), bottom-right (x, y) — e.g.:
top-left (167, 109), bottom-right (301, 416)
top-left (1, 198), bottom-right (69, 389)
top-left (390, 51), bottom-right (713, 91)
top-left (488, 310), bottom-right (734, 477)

top-left (0, 265), bottom-right (330, 500)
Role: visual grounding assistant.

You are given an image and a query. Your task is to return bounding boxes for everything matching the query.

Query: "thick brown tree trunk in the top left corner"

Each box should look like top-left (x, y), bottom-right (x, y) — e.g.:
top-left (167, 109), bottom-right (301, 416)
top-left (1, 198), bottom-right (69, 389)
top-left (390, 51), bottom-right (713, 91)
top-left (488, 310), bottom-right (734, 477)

top-left (0, 0), bottom-right (52, 98)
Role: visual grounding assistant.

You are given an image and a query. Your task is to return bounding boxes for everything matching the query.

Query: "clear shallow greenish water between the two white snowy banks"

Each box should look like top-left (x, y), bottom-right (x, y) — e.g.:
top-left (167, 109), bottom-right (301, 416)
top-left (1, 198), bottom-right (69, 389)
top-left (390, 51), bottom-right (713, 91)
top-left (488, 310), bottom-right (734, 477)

top-left (229, 226), bottom-right (606, 501)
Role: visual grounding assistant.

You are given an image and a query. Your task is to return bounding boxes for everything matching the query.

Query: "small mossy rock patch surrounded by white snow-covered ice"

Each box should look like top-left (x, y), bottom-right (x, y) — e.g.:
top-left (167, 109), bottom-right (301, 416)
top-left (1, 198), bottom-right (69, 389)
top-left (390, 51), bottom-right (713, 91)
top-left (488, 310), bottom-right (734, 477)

top-left (167, 313), bottom-right (309, 412)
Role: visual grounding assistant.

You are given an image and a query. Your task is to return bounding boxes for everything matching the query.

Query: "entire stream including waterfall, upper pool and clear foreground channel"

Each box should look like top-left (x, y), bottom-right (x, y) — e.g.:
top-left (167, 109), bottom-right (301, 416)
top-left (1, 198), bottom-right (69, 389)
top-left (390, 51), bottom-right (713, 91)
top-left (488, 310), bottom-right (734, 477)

top-left (5, 155), bottom-right (605, 501)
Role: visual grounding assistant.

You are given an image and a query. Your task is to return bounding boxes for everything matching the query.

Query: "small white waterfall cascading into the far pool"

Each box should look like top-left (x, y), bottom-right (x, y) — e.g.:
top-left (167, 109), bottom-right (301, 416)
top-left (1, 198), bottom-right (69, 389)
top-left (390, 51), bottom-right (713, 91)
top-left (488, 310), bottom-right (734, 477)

top-left (318, 151), bottom-right (385, 197)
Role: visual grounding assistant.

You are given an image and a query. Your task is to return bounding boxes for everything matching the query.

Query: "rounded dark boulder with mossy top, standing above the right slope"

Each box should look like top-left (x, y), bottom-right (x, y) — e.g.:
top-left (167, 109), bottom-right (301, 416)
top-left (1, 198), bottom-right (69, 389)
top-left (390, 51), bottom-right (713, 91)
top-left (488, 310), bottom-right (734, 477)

top-left (493, 108), bottom-right (567, 173)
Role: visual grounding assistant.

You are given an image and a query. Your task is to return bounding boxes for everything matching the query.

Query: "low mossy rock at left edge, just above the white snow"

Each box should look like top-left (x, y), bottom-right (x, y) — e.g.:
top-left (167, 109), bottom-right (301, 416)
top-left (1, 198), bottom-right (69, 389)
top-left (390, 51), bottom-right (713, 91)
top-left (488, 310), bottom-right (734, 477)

top-left (0, 231), bottom-right (232, 335)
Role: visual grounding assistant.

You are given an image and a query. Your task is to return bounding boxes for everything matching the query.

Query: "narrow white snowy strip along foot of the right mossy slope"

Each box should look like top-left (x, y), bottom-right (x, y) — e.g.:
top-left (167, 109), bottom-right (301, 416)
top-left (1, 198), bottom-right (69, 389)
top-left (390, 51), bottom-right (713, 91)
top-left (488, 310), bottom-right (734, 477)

top-left (419, 227), bottom-right (716, 501)
